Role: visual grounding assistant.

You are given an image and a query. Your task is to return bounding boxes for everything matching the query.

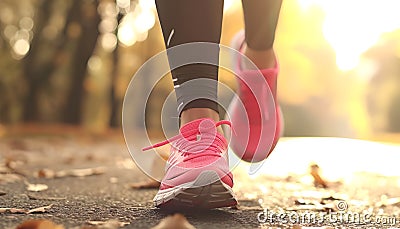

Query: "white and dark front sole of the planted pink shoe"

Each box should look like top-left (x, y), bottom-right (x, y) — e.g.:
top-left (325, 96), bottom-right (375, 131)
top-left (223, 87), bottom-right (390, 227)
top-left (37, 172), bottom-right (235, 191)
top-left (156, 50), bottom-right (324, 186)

top-left (153, 170), bottom-right (237, 209)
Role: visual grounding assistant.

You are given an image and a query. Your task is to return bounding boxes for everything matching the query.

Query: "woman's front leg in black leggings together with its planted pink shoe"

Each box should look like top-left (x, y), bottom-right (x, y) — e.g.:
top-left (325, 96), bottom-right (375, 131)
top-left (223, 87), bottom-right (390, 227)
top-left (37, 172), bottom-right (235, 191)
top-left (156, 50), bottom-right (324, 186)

top-left (150, 0), bottom-right (237, 209)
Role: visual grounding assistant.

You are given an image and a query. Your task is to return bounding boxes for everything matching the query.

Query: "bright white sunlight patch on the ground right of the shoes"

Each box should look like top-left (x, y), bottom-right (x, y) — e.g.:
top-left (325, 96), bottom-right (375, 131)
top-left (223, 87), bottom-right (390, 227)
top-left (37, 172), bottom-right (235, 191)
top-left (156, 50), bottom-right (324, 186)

top-left (244, 137), bottom-right (400, 179)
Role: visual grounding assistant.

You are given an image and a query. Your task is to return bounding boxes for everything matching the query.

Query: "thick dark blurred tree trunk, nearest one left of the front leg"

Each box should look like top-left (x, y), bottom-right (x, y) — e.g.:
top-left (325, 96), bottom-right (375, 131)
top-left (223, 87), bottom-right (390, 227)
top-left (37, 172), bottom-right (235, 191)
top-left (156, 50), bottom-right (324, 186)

top-left (63, 0), bottom-right (100, 124)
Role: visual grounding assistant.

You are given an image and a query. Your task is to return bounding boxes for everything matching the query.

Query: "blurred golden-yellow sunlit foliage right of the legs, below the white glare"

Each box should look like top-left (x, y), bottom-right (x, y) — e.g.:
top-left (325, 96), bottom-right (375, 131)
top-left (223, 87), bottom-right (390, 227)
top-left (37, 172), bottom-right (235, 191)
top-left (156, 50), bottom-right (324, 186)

top-left (223, 0), bottom-right (400, 139)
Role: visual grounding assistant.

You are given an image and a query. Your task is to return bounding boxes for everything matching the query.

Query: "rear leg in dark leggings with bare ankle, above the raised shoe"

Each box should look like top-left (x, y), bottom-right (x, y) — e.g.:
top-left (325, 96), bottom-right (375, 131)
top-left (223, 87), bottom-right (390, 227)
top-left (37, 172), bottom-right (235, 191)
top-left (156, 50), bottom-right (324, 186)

top-left (242, 0), bottom-right (282, 69)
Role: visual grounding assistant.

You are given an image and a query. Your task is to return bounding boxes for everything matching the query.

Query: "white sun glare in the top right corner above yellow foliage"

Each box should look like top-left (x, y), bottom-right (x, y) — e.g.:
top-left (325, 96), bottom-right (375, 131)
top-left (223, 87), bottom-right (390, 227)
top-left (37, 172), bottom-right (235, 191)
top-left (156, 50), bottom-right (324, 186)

top-left (298, 0), bottom-right (400, 71)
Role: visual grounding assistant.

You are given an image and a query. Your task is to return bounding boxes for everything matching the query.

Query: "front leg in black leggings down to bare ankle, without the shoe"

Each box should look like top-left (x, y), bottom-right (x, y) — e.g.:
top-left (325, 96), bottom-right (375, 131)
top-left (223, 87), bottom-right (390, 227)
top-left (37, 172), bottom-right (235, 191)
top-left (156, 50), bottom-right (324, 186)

top-left (156, 0), bottom-right (223, 125)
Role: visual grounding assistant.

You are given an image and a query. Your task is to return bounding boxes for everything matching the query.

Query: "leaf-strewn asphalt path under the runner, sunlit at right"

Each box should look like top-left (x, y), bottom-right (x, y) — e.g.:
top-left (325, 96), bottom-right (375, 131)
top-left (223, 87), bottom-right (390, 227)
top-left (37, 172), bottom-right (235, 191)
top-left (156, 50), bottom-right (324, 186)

top-left (0, 130), bottom-right (400, 228)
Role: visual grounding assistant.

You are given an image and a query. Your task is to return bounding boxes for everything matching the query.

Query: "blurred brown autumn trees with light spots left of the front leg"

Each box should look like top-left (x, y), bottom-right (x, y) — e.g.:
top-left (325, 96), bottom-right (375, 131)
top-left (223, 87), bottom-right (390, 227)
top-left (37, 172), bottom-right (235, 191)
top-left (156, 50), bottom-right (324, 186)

top-left (0, 0), bottom-right (162, 131)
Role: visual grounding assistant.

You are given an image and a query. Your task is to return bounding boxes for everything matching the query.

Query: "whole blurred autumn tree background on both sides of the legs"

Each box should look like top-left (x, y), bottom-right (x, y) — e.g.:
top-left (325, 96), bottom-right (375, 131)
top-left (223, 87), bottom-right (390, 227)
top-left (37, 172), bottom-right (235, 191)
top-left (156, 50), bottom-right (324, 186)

top-left (0, 0), bottom-right (400, 138)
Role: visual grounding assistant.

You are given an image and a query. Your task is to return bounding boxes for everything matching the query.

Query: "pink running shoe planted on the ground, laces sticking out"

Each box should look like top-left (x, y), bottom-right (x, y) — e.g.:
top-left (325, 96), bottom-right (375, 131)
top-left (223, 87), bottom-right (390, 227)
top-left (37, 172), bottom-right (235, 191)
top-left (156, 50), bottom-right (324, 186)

top-left (143, 118), bottom-right (237, 209)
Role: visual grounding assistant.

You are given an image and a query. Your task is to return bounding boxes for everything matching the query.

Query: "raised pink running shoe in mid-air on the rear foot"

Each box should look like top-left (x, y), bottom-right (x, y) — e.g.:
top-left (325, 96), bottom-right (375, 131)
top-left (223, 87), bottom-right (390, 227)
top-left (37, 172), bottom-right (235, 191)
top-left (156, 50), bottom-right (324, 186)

top-left (228, 31), bottom-right (283, 162)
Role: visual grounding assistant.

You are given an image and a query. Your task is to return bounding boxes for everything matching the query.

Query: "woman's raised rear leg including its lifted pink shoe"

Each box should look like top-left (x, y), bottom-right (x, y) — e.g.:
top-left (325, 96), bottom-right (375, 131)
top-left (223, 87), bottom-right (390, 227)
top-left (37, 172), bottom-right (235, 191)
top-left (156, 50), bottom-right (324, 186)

top-left (229, 0), bottom-right (283, 162)
